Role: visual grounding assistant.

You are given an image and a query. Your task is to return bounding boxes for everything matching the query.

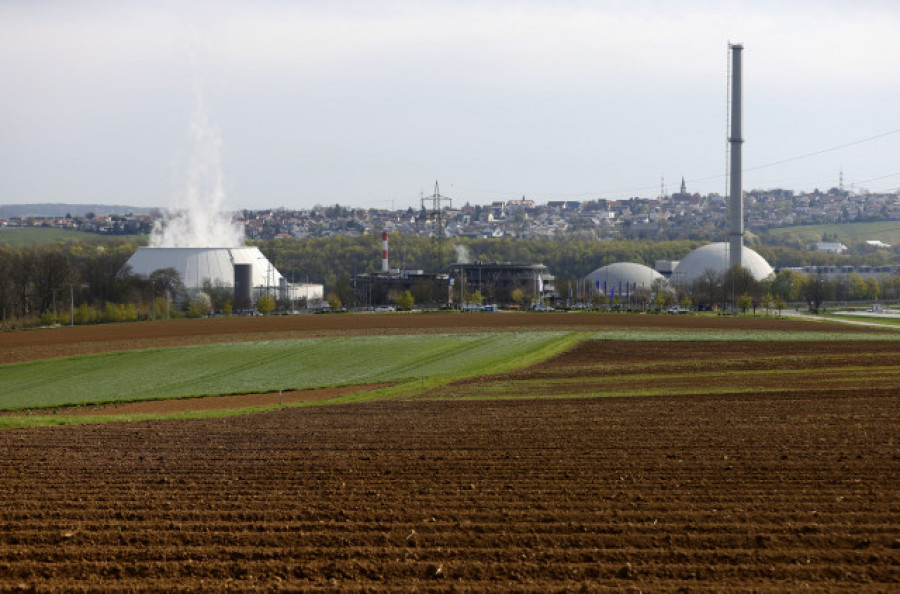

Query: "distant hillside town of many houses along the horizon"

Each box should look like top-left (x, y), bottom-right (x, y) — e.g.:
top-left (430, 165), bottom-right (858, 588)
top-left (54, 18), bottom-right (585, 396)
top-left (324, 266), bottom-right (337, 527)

top-left (0, 182), bottom-right (900, 240)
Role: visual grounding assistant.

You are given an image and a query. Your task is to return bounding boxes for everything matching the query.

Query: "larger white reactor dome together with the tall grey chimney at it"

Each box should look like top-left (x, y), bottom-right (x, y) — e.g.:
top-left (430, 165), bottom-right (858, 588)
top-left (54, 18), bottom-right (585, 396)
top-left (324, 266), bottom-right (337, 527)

top-left (670, 44), bottom-right (774, 285)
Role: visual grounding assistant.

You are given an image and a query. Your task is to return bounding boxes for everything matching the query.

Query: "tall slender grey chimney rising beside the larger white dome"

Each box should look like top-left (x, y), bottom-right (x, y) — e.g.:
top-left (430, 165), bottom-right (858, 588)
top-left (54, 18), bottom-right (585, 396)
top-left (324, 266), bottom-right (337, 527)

top-left (728, 44), bottom-right (744, 268)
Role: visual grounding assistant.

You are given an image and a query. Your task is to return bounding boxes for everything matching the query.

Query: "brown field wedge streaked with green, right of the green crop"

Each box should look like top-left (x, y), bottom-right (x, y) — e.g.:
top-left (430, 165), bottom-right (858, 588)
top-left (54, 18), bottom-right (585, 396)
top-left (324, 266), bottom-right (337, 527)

top-left (422, 340), bottom-right (900, 398)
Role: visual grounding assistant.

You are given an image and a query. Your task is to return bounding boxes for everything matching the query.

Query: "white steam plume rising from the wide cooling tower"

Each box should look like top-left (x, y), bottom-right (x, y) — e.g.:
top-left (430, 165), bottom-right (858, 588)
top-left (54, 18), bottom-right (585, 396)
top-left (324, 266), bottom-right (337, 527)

top-left (150, 91), bottom-right (244, 247)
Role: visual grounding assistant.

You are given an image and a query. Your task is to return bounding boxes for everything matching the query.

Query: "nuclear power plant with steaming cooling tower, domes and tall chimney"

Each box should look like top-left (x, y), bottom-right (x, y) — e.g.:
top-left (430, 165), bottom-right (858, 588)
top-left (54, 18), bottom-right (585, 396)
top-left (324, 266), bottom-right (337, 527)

top-left (127, 44), bottom-right (774, 306)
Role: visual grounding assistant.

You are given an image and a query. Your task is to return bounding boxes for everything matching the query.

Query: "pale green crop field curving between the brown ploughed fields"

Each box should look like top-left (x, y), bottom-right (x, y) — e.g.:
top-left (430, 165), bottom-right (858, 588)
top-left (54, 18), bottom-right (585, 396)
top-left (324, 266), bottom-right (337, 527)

top-left (0, 332), bottom-right (580, 410)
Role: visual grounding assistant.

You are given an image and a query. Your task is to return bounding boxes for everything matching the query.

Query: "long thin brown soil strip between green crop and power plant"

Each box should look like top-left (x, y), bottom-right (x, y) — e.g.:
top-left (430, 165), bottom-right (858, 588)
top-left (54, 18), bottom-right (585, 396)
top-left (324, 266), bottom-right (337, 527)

top-left (0, 312), bottom-right (891, 365)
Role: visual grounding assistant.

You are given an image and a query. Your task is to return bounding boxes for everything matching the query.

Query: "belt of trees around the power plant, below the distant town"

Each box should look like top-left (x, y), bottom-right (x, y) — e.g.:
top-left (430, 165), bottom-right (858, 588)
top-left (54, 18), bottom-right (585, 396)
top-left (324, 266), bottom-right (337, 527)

top-left (0, 233), bottom-right (900, 328)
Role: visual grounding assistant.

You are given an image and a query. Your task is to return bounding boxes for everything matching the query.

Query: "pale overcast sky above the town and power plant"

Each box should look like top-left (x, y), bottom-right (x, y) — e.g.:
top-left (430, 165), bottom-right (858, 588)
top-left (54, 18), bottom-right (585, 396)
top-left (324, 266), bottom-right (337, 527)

top-left (0, 0), bottom-right (900, 208)
